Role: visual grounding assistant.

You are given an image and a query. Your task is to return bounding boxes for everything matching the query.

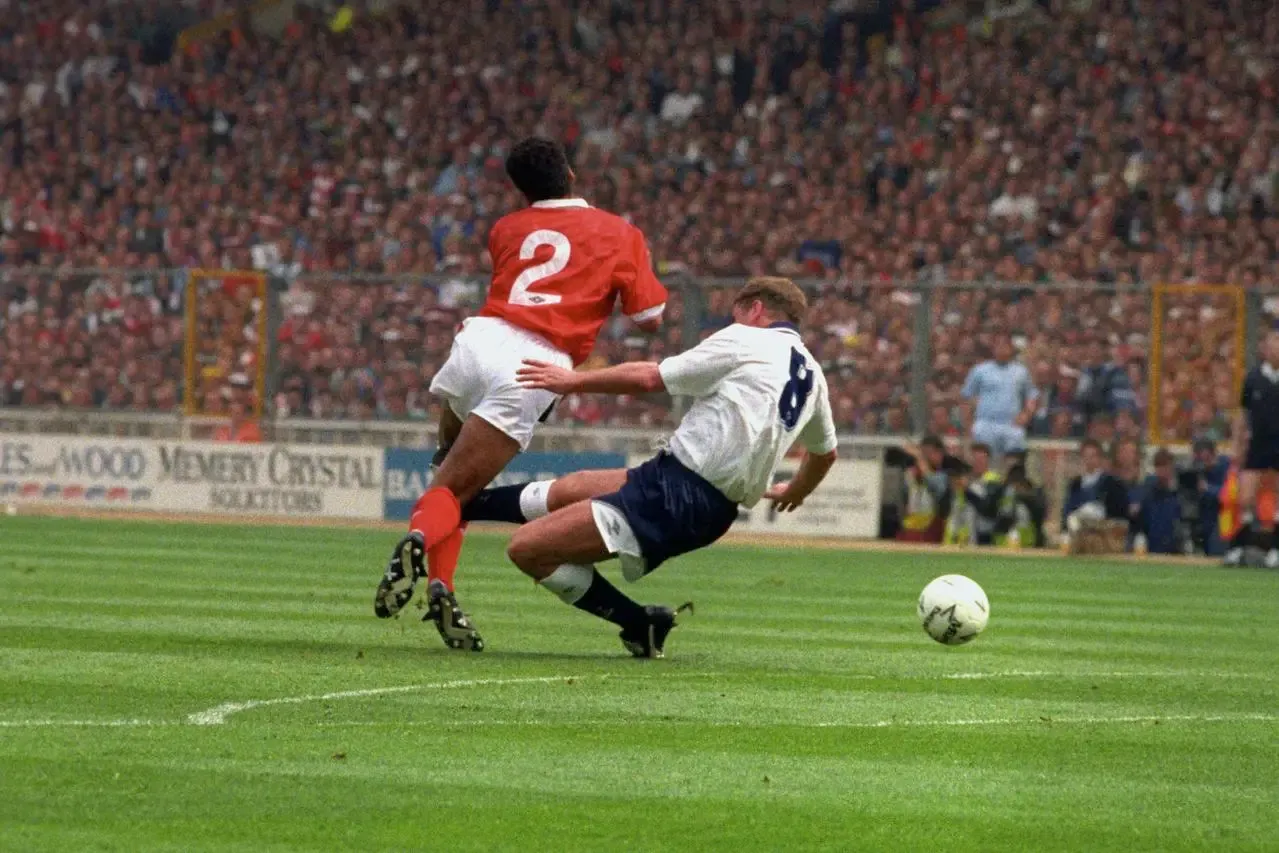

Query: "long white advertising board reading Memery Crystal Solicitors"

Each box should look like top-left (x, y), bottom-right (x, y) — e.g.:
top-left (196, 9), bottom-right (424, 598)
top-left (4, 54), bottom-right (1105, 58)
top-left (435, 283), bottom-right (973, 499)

top-left (0, 435), bottom-right (382, 518)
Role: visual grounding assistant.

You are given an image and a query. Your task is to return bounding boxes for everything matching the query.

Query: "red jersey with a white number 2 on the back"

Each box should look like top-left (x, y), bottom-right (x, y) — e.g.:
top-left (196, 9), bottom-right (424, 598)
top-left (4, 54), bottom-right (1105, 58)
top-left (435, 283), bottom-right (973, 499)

top-left (480, 198), bottom-right (666, 364)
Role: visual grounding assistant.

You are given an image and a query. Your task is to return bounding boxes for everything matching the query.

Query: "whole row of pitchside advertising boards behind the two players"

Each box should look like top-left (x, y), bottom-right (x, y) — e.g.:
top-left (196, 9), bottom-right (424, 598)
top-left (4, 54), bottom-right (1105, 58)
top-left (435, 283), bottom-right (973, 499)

top-left (0, 434), bottom-right (883, 538)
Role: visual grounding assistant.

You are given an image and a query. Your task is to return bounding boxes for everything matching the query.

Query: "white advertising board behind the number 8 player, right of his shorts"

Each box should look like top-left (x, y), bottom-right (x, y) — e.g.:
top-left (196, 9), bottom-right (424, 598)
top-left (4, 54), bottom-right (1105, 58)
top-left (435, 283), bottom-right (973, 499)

top-left (631, 457), bottom-right (884, 538)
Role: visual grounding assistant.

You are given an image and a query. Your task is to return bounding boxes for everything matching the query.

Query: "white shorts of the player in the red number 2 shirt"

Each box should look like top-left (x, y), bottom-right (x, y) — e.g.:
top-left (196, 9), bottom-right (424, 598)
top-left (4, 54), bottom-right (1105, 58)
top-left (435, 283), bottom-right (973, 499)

top-left (431, 317), bottom-right (573, 450)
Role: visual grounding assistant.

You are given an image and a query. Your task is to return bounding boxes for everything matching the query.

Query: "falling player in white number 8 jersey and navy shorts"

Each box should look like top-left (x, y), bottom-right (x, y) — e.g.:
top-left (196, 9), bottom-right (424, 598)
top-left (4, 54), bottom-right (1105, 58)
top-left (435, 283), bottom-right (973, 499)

top-left (506, 278), bottom-right (836, 657)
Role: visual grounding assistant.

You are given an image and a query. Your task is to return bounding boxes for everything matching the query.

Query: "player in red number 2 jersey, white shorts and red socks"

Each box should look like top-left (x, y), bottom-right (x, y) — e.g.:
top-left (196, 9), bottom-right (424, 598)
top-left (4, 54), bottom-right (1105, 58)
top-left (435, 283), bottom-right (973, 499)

top-left (373, 137), bottom-right (666, 651)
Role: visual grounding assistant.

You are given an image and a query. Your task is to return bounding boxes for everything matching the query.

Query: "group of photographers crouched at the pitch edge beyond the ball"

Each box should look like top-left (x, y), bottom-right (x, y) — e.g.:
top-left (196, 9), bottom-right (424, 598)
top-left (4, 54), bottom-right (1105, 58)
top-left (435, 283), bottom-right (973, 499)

top-left (883, 434), bottom-right (1248, 556)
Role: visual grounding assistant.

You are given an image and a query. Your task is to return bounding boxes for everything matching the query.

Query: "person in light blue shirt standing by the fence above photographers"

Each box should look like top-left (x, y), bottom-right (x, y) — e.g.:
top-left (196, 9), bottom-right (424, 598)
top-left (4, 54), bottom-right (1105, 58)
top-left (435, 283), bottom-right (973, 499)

top-left (961, 334), bottom-right (1039, 458)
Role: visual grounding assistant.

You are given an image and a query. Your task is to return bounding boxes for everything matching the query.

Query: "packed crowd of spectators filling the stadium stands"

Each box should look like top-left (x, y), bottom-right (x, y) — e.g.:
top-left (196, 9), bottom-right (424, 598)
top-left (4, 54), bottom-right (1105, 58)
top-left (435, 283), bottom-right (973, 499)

top-left (0, 0), bottom-right (1279, 439)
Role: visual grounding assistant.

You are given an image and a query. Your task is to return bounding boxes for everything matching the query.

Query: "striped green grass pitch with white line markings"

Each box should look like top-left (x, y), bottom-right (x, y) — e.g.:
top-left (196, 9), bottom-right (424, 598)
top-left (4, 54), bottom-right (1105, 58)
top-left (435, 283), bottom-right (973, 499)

top-left (0, 517), bottom-right (1279, 853)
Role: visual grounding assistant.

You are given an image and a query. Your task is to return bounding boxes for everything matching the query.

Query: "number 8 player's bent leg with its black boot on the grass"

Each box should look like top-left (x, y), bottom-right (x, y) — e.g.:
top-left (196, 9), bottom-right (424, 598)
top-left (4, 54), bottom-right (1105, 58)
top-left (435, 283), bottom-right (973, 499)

top-left (506, 500), bottom-right (678, 657)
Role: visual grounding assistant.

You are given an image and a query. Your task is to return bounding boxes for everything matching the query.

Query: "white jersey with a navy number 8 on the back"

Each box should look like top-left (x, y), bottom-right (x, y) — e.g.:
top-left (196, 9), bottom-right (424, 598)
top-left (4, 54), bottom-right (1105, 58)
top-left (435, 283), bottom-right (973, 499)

top-left (657, 324), bottom-right (836, 506)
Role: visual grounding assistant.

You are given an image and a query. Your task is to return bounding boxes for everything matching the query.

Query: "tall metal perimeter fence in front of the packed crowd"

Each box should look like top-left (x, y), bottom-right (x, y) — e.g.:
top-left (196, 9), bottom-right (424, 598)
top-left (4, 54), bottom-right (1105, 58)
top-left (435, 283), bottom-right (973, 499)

top-left (0, 269), bottom-right (1279, 442)
